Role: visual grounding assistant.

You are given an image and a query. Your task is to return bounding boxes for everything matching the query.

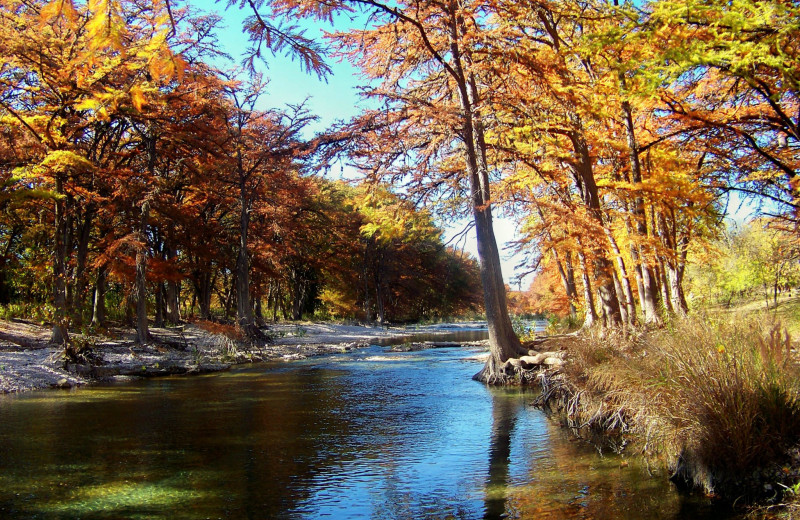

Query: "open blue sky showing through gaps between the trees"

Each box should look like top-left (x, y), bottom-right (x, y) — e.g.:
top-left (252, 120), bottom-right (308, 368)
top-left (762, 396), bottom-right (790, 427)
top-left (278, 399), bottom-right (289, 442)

top-left (190, 0), bottom-right (530, 289)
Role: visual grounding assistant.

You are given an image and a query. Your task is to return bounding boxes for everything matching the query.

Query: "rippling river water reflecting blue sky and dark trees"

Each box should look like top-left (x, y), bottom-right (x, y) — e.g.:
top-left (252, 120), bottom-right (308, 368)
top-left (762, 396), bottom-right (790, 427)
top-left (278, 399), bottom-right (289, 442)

top-left (0, 346), bottom-right (732, 520)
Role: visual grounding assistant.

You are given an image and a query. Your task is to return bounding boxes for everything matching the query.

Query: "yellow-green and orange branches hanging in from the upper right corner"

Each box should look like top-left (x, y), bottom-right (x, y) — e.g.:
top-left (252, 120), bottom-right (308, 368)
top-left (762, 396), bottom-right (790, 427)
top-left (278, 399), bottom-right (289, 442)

top-left (643, 0), bottom-right (800, 222)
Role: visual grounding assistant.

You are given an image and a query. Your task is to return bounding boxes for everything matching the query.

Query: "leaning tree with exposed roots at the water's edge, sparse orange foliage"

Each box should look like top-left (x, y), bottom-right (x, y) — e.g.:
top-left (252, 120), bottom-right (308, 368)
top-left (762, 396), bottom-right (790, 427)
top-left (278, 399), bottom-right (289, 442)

top-left (268, 0), bottom-right (524, 383)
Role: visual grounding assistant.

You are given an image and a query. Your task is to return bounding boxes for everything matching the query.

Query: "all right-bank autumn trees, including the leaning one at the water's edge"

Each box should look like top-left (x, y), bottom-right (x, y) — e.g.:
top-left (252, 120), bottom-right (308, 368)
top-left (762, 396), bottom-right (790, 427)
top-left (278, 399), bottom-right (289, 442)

top-left (258, 0), bottom-right (800, 381)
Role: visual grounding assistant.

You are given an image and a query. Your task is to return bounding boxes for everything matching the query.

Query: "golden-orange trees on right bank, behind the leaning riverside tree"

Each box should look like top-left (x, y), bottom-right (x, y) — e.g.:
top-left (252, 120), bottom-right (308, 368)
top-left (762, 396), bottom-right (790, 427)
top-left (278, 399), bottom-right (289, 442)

top-left (496, 0), bottom-right (800, 325)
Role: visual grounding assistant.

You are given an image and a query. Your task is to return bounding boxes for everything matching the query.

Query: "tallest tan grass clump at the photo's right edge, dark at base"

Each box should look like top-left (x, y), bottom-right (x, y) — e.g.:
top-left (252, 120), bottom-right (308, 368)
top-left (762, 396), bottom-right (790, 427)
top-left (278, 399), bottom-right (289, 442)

top-left (651, 320), bottom-right (800, 492)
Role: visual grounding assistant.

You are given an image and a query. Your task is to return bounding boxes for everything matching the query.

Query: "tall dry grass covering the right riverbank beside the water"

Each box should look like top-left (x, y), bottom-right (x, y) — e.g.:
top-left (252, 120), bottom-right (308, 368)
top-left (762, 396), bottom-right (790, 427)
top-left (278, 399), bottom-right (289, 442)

top-left (541, 317), bottom-right (800, 500)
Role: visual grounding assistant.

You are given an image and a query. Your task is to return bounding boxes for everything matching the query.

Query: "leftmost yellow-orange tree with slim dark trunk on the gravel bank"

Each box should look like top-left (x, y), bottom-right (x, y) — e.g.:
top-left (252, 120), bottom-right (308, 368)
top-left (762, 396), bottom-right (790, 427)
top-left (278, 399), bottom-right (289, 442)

top-left (0, 0), bottom-right (175, 344)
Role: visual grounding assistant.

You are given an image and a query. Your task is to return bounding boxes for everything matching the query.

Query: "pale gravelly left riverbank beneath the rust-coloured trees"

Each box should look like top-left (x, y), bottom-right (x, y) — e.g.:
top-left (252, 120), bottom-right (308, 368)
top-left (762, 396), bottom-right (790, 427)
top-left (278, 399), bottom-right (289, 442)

top-left (0, 320), bottom-right (488, 394)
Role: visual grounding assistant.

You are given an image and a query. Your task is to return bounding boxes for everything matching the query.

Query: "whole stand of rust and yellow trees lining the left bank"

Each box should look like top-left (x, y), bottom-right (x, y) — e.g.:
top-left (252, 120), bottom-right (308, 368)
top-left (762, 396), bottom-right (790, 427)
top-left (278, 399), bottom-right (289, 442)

top-left (0, 0), bottom-right (480, 343)
